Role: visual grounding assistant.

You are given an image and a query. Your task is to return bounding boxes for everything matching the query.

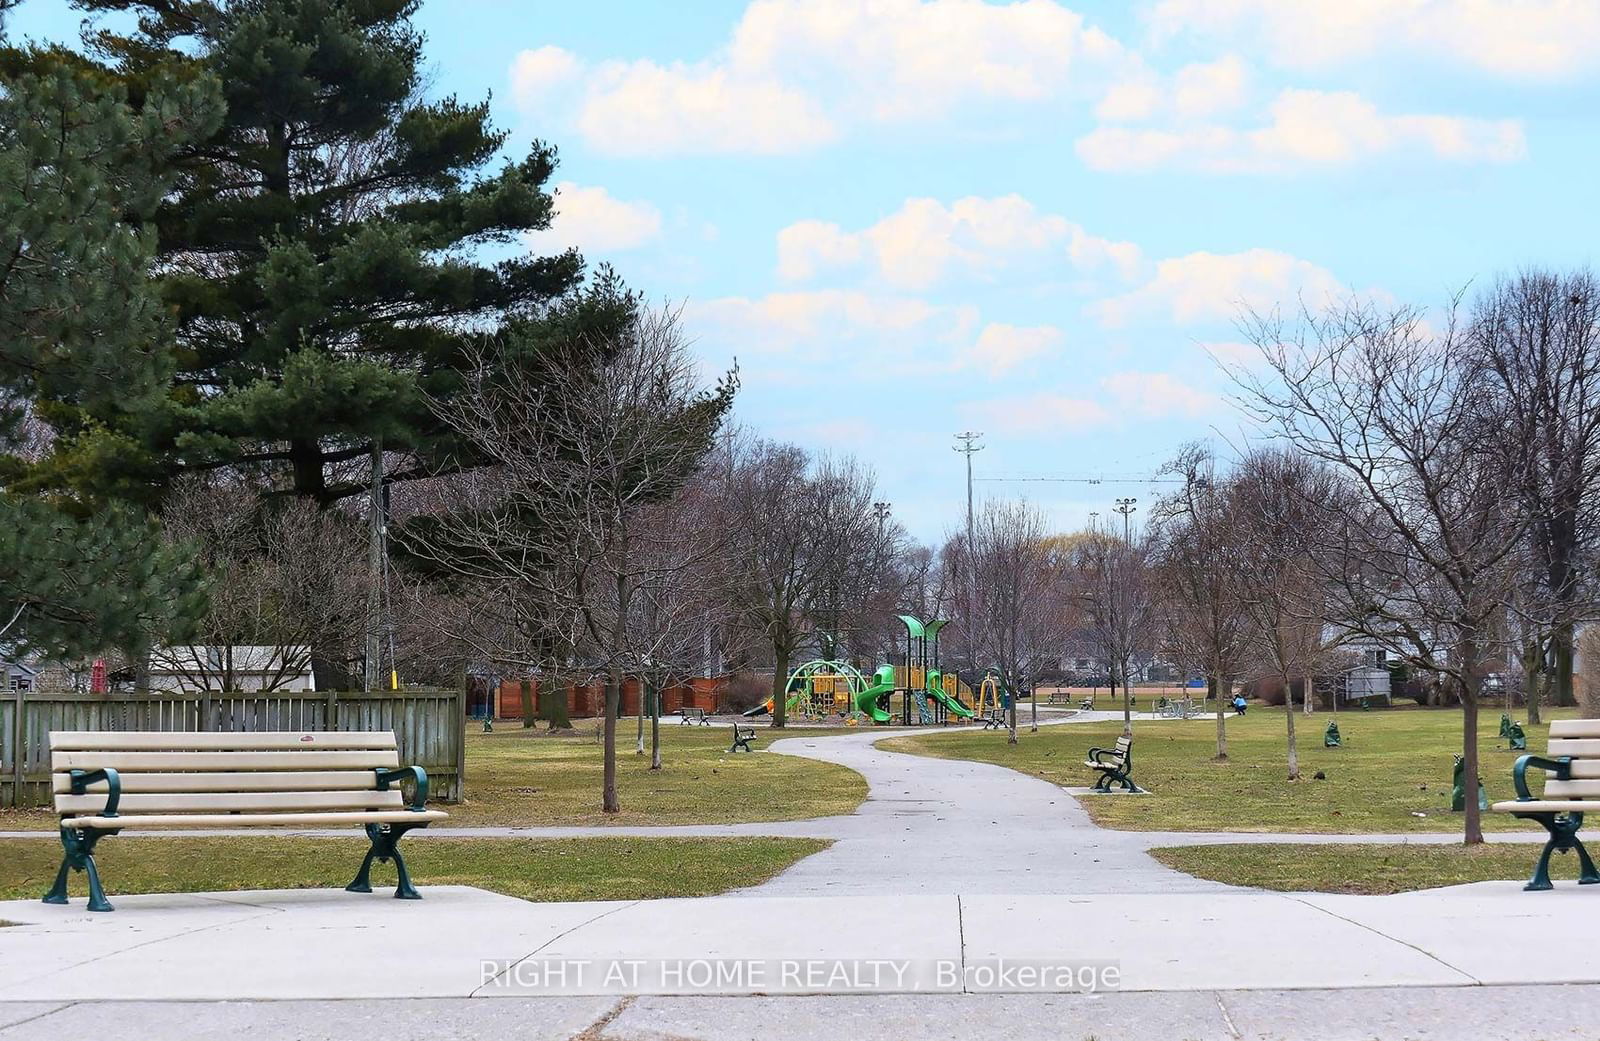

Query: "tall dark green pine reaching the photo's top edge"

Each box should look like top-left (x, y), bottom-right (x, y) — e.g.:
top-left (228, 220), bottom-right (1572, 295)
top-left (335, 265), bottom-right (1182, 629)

top-left (48, 0), bottom-right (617, 505)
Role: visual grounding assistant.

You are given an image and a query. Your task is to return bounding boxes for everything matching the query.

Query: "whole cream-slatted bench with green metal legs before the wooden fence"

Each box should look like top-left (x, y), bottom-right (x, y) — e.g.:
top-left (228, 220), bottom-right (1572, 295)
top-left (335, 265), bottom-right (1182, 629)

top-left (45, 731), bottom-right (448, 911)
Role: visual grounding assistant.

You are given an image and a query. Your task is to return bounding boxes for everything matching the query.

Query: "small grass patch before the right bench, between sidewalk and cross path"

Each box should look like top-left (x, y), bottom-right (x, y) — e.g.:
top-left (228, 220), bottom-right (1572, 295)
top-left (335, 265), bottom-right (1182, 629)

top-left (1150, 843), bottom-right (1578, 894)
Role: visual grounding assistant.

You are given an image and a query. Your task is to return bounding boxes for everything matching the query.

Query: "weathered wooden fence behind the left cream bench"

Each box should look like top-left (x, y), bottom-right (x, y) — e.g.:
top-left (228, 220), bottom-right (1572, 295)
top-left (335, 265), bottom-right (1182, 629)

top-left (0, 691), bottom-right (467, 806)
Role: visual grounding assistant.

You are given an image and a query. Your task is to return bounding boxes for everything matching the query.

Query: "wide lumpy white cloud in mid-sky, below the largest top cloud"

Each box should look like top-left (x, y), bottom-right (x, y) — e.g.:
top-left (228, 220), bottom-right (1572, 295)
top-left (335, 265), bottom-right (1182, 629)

top-left (778, 195), bottom-right (1139, 288)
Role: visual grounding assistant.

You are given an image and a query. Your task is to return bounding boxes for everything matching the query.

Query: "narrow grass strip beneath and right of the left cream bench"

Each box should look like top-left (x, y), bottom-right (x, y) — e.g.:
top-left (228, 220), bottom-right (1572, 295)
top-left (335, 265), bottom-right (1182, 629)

top-left (0, 835), bottom-right (829, 900)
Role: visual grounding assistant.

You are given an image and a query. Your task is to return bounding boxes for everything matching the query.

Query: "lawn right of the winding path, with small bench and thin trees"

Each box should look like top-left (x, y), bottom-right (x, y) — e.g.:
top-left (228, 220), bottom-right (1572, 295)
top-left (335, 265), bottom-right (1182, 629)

top-left (883, 705), bottom-right (1573, 837)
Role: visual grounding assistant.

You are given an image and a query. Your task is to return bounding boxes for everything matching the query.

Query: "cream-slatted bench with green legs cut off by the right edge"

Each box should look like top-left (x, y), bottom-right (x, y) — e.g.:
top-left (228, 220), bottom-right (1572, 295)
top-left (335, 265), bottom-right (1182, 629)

top-left (1491, 720), bottom-right (1600, 891)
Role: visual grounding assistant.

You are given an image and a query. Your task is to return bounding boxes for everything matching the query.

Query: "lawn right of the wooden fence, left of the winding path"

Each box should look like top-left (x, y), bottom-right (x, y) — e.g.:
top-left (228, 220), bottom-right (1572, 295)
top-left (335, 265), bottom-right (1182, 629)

top-left (0, 720), bottom-right (867, 832)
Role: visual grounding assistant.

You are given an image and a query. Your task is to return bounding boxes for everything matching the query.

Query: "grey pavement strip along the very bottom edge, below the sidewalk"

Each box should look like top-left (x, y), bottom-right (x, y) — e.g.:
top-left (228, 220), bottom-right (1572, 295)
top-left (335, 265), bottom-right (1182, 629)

top-left (0, 987), bottom-right (1600, 1041)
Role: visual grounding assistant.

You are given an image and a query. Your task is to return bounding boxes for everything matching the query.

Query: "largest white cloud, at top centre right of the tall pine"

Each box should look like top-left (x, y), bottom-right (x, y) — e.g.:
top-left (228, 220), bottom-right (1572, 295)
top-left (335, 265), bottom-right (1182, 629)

top-left (512, 0), bottom-right (1134, 155)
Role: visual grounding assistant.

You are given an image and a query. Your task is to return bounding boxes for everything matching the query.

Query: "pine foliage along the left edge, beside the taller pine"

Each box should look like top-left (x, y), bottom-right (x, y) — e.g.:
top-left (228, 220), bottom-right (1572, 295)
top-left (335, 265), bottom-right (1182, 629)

top-left (0, 56), bottom-right (219, 656)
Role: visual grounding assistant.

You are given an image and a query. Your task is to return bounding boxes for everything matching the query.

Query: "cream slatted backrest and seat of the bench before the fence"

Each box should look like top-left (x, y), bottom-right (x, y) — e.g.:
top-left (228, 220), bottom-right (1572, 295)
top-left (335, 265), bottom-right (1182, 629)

top-left (50, 731), bottom-right (405, 817)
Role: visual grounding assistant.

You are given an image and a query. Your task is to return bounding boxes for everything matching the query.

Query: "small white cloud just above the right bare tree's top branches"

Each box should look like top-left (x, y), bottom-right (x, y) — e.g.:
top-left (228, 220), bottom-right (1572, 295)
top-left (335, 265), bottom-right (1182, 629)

top-left (1094, 249), bottom-right (1342, 326)
